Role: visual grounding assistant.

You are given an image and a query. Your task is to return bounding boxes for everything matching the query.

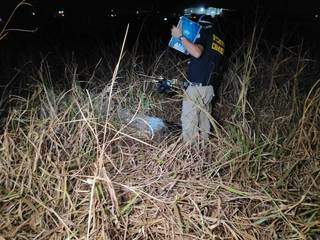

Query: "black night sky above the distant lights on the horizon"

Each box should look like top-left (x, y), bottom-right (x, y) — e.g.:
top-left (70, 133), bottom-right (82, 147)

top-left (0, 0), bottom-right (320, 16)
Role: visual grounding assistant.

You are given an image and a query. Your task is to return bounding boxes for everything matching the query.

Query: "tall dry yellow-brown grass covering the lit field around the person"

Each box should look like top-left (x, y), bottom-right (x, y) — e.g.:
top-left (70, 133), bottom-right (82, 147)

top-left (0, 26), bottom-right (320, 239)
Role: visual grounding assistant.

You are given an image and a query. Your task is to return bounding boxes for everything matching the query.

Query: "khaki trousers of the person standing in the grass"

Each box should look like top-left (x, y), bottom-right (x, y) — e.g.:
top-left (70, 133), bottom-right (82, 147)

top-left (181, 86), bottom-right (214, 143)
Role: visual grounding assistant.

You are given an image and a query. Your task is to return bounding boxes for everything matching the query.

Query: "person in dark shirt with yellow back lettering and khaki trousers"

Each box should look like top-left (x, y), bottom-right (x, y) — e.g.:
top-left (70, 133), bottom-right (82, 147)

top-left (171, 15), bottom-right (225, 143)
